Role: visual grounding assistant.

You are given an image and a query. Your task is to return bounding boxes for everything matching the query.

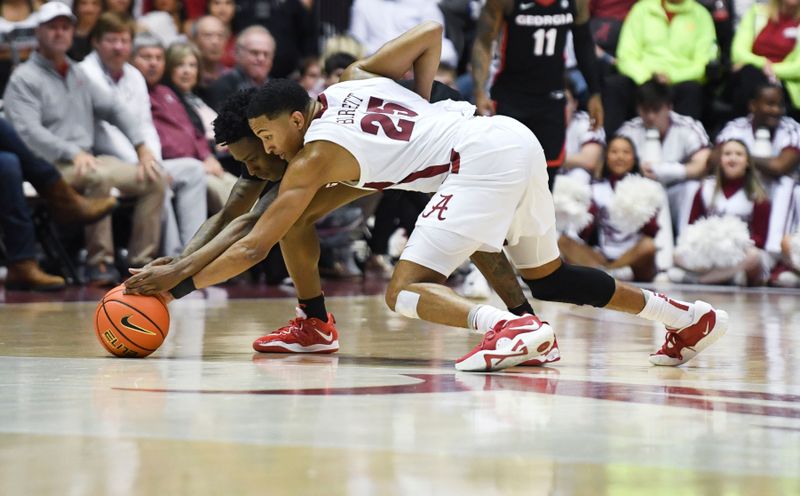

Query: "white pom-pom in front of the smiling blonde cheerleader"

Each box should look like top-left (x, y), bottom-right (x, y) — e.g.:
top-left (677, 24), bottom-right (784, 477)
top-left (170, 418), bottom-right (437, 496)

top-left (675, 216), bottom-right (753, 272)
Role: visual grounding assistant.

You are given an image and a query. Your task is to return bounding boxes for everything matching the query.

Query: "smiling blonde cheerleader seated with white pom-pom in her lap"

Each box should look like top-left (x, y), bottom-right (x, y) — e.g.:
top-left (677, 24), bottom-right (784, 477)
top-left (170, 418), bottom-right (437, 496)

top-left (667, 139), bottom-right (772, 286)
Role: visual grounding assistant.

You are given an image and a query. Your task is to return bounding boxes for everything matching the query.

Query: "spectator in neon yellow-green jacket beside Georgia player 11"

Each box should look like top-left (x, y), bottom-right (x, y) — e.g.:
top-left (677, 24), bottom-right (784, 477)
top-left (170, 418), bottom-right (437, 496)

top-left (603, 0), bottom-right (717, 133)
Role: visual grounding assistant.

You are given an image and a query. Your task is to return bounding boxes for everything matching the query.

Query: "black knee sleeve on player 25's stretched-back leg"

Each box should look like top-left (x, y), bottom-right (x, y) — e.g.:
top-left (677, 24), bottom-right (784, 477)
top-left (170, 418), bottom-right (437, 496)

top-left (525, 263), bottom-right (617, 307)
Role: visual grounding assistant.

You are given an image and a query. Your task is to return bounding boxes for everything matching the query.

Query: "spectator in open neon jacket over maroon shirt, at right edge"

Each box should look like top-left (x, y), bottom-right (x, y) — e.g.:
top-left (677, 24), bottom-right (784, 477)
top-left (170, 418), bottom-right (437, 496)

top-left (731, 0), bottom-right (800, 119)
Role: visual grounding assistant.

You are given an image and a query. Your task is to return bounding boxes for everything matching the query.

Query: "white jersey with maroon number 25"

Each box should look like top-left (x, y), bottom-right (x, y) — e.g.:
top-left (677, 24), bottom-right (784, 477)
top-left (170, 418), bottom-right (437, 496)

top-left (304, 78), bottom-right (475, 193)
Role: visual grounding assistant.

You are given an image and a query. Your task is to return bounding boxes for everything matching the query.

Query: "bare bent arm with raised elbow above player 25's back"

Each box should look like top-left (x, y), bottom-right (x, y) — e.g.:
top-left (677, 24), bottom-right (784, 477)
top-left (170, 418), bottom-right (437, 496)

top-left (342, 21), bottom-right (444, 100)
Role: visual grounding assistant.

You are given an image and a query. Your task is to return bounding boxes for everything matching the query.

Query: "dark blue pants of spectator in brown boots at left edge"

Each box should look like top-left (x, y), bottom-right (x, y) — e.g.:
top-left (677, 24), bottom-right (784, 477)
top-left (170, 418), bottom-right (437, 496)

top-left (0, 119), bottom-right (61, 262)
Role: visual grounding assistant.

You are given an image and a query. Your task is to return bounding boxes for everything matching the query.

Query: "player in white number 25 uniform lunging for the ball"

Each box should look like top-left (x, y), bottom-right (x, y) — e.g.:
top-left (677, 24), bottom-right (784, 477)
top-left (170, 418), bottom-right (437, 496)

top-left (126, 23), bottom-right (728, 371)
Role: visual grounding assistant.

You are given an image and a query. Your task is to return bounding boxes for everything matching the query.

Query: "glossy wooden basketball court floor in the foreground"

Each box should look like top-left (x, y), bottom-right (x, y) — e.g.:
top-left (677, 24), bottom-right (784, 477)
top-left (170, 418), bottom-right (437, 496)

top-left (0, 280), bottom-right (800, 496)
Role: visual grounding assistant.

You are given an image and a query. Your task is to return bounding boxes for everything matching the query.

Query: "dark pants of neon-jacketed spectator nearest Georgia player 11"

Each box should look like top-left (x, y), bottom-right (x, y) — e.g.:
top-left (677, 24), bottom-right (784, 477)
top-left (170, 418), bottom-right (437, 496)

top-left (603, 74), bottom-right (703, 137)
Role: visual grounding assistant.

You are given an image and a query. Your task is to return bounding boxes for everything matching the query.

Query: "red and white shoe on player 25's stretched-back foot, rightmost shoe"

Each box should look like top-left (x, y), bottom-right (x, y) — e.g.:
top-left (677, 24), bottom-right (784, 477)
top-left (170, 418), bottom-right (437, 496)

top-left (650, 300), bottom-right (728, 366)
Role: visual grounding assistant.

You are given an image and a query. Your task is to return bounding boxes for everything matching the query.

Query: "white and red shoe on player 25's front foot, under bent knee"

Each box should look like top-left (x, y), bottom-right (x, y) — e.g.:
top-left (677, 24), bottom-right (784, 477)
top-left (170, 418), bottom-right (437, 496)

top-left (456, 315), bottom-right (555, 372)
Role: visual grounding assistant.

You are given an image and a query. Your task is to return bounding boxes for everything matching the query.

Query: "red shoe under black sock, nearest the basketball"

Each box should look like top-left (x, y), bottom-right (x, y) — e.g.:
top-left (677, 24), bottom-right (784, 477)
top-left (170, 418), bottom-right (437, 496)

top-left (253, 308), bottom-right (339, 353)
